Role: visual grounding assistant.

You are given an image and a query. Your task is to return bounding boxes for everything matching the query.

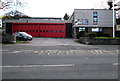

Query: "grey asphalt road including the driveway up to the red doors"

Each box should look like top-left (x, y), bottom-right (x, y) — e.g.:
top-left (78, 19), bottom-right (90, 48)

top-left (1, 38), bottom-right (119, 79)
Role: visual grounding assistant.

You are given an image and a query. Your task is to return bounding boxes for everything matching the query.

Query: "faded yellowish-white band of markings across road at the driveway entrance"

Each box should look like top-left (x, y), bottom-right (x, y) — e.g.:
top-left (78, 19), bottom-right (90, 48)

top-left (3, 50), bottom-right (120, 55)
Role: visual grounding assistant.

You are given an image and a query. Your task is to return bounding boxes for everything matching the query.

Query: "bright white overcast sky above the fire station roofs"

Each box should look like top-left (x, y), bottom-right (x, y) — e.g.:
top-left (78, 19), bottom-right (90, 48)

top-left (0, 0), bottom-right (119, 18)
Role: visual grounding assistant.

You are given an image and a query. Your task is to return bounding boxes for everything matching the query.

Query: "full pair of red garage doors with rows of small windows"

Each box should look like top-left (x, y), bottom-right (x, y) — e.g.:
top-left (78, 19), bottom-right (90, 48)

top-left (12, 23), bottom-right (66, 37)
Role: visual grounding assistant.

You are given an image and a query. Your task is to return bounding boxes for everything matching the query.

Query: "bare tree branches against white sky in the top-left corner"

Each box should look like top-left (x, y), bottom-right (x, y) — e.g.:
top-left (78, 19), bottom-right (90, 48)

top-left (0, 0), bottom-right (26, 10)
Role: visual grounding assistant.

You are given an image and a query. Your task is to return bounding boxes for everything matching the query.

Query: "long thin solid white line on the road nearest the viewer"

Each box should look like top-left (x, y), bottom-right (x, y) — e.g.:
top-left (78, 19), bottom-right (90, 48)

top-left (0, 64), bottom-right (74, 68)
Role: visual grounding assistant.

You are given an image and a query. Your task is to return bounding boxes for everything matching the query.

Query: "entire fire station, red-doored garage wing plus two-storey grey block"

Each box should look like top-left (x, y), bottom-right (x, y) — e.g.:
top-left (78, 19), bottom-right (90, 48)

top-left (4, 9), bottom-right (116, 38)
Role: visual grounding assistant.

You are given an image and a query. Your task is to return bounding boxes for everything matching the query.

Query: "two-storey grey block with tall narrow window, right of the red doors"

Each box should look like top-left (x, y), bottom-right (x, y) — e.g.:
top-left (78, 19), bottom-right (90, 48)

top-left (70, 9), bottom-right (116, 36)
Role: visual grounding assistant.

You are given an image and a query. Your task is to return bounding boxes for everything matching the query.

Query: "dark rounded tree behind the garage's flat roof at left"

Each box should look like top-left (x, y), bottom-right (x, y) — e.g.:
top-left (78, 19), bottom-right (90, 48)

top-left (2, 10), bottom-right (30, 20)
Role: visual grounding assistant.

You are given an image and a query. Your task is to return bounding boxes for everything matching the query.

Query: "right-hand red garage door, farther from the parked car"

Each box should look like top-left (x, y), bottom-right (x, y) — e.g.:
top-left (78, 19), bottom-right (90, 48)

top-left (39, 23), bottom-right (66, 37)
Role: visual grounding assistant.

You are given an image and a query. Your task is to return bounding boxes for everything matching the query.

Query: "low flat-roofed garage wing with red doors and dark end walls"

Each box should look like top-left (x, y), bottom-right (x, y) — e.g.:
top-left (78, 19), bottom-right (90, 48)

top-left (4, 18), bottom-right (72, 38)
